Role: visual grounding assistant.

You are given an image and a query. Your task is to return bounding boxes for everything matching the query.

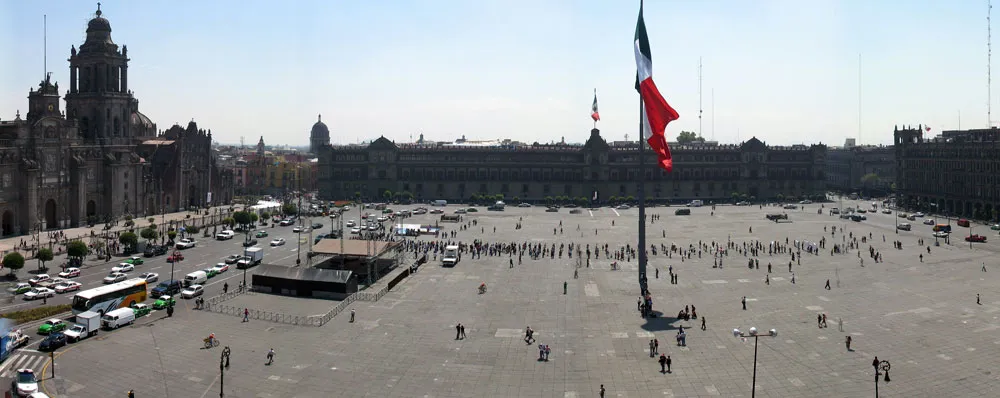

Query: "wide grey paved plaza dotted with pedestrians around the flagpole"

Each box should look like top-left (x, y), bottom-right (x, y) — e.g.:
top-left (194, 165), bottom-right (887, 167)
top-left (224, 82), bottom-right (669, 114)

top-left (31, 203), bottom-right (1000, 398)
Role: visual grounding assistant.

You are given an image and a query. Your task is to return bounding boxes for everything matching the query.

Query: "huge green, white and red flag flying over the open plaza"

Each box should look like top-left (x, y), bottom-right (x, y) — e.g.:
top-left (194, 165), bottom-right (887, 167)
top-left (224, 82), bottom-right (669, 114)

top-left (634, 2), bottom-right (680, 171)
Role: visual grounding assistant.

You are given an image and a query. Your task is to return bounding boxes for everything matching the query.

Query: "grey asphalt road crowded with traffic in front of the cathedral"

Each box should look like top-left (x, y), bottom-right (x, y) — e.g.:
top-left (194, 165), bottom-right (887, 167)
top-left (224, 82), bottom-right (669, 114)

top-left (0, 217), bottom-right (331, 312)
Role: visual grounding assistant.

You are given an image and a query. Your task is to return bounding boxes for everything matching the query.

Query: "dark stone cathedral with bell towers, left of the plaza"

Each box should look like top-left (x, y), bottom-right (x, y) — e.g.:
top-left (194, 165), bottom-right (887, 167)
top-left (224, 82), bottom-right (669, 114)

top-left (0, 7), bottom-right (232, 236)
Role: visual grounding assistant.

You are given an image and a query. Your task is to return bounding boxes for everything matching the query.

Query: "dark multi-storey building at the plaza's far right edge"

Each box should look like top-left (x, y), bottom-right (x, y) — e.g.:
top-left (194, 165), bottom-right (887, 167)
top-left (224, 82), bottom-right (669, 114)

top-left (893, 126), bottom-right (1000, 220)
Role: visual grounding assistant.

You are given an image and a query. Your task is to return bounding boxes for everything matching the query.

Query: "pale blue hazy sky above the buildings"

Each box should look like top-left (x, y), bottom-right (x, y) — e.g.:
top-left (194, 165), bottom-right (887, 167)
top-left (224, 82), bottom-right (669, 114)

top-left (0, 0), bottom-right (1000, 146)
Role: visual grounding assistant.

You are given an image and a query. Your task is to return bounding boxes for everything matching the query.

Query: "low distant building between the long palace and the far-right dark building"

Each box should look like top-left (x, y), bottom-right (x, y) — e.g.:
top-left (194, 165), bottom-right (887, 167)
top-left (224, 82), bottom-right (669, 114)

top-left (826, 146), bottom-right (896, 194)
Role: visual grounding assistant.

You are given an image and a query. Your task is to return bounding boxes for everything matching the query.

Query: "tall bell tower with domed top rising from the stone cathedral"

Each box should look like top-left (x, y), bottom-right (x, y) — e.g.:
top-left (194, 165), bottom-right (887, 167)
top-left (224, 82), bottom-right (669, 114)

top-left (66, 3), bottom-right (133, 142)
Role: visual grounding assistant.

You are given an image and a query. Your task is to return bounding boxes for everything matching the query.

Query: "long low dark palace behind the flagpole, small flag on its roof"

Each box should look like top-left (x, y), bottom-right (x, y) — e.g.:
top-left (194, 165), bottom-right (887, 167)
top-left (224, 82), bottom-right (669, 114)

top-left (319, 129), bottom-right (826, 202)
